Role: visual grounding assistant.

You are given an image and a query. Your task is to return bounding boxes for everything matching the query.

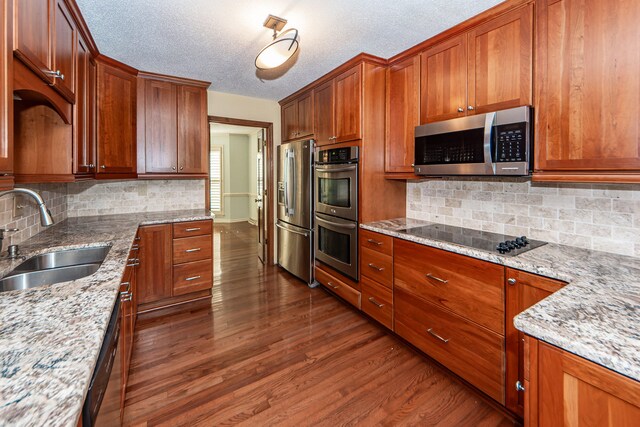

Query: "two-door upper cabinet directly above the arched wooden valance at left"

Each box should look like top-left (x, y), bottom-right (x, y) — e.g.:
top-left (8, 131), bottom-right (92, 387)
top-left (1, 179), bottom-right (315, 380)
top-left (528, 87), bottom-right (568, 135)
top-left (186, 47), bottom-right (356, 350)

top-left (13, 0), bottom-right (77, 103)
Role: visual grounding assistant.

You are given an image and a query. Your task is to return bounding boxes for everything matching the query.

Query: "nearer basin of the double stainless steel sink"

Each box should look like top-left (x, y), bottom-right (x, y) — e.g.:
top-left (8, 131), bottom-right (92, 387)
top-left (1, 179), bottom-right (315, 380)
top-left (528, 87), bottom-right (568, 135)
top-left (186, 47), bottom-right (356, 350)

top-left (0, 263), bottom-right (100, 292)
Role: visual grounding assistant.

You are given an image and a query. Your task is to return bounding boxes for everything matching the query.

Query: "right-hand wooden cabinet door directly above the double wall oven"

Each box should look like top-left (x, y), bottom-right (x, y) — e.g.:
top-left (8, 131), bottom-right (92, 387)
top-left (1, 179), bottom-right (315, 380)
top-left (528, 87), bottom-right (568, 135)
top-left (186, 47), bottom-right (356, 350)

top-left (335, 65), bottom-right (362, 142)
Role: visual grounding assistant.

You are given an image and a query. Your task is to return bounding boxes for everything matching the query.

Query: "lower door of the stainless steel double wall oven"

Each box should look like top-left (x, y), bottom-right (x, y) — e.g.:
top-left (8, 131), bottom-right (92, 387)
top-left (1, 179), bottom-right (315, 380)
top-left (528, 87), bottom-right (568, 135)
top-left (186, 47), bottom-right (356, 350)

top-left (315, 212), bottom-right (358, 281)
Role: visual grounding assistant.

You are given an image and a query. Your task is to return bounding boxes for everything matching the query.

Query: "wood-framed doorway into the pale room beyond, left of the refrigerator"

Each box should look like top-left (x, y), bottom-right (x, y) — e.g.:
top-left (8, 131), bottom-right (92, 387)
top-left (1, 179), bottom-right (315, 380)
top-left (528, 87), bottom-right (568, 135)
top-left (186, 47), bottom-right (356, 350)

top-left (206, 116), bottom-right (274, 264)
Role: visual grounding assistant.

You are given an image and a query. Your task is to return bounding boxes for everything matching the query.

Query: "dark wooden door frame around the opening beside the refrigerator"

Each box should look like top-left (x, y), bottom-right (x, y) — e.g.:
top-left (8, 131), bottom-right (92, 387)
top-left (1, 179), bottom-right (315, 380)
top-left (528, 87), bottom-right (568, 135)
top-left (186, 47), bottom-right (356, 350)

top-left (205, 116), bottom-right (275, 265)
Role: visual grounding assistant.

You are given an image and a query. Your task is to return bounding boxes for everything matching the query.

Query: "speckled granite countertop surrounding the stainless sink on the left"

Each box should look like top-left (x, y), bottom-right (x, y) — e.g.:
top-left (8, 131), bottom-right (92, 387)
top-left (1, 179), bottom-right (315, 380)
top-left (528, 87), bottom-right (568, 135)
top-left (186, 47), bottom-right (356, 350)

top-left (0, 210), bottom-right (212, 426)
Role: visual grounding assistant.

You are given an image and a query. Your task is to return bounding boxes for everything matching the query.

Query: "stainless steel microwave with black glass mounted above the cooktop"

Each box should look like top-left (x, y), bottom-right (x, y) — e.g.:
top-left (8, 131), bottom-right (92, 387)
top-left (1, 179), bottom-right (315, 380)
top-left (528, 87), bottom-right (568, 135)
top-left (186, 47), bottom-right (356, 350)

top-left (414, 106), bottom-right (533, 176)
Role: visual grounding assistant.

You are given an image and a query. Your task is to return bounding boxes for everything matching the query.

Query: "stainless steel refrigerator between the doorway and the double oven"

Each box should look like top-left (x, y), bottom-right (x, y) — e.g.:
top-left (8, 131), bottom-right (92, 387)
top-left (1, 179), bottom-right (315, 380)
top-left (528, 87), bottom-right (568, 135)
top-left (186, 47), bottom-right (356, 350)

top-left (276, 140), bottom-right (313, 283)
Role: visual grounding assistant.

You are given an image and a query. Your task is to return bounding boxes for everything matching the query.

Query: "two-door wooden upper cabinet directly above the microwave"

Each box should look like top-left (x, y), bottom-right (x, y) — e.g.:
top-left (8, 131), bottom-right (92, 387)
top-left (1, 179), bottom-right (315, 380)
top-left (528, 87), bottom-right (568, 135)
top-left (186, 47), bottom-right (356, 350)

top-left (420, 4), bottom-right (533, 123)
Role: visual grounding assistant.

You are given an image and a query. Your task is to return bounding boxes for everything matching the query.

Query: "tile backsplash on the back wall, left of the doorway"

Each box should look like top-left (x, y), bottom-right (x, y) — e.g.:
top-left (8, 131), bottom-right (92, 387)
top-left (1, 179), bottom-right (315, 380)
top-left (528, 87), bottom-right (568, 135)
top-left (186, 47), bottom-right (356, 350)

top-left (67, 179), bottom-right (205, 217)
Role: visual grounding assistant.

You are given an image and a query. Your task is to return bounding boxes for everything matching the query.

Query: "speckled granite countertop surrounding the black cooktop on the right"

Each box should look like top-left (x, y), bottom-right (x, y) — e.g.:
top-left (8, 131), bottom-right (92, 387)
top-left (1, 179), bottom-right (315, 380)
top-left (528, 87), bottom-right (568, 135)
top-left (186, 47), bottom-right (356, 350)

top-left (360, 218), bottom-right (640, 381)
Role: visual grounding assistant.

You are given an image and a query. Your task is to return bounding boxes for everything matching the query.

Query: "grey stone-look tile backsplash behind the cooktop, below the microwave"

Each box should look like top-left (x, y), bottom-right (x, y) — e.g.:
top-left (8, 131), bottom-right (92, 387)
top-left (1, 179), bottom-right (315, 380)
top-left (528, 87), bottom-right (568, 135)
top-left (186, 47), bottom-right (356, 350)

top-left (407, 178), bottom-right (640, 257)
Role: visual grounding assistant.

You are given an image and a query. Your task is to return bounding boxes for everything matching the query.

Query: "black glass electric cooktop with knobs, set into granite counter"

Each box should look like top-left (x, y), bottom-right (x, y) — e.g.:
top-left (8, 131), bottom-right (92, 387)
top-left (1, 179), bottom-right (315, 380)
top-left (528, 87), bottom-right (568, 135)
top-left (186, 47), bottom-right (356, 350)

top-left (398, 224), bottom-right (547, 256)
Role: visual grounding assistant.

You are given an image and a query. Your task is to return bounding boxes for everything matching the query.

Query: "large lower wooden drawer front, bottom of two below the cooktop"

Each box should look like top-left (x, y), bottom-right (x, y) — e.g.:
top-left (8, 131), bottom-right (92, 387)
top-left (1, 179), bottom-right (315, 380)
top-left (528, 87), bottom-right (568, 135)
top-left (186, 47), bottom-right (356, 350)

top-left (394, 289), bottom-right (504, 404)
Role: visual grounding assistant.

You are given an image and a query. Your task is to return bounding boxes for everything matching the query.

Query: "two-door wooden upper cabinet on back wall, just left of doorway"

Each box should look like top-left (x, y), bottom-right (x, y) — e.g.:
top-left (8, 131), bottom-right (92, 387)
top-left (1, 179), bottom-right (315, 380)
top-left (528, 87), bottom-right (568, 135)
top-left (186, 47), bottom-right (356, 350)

top-left (138, 73), bottom-right (209, 178)
